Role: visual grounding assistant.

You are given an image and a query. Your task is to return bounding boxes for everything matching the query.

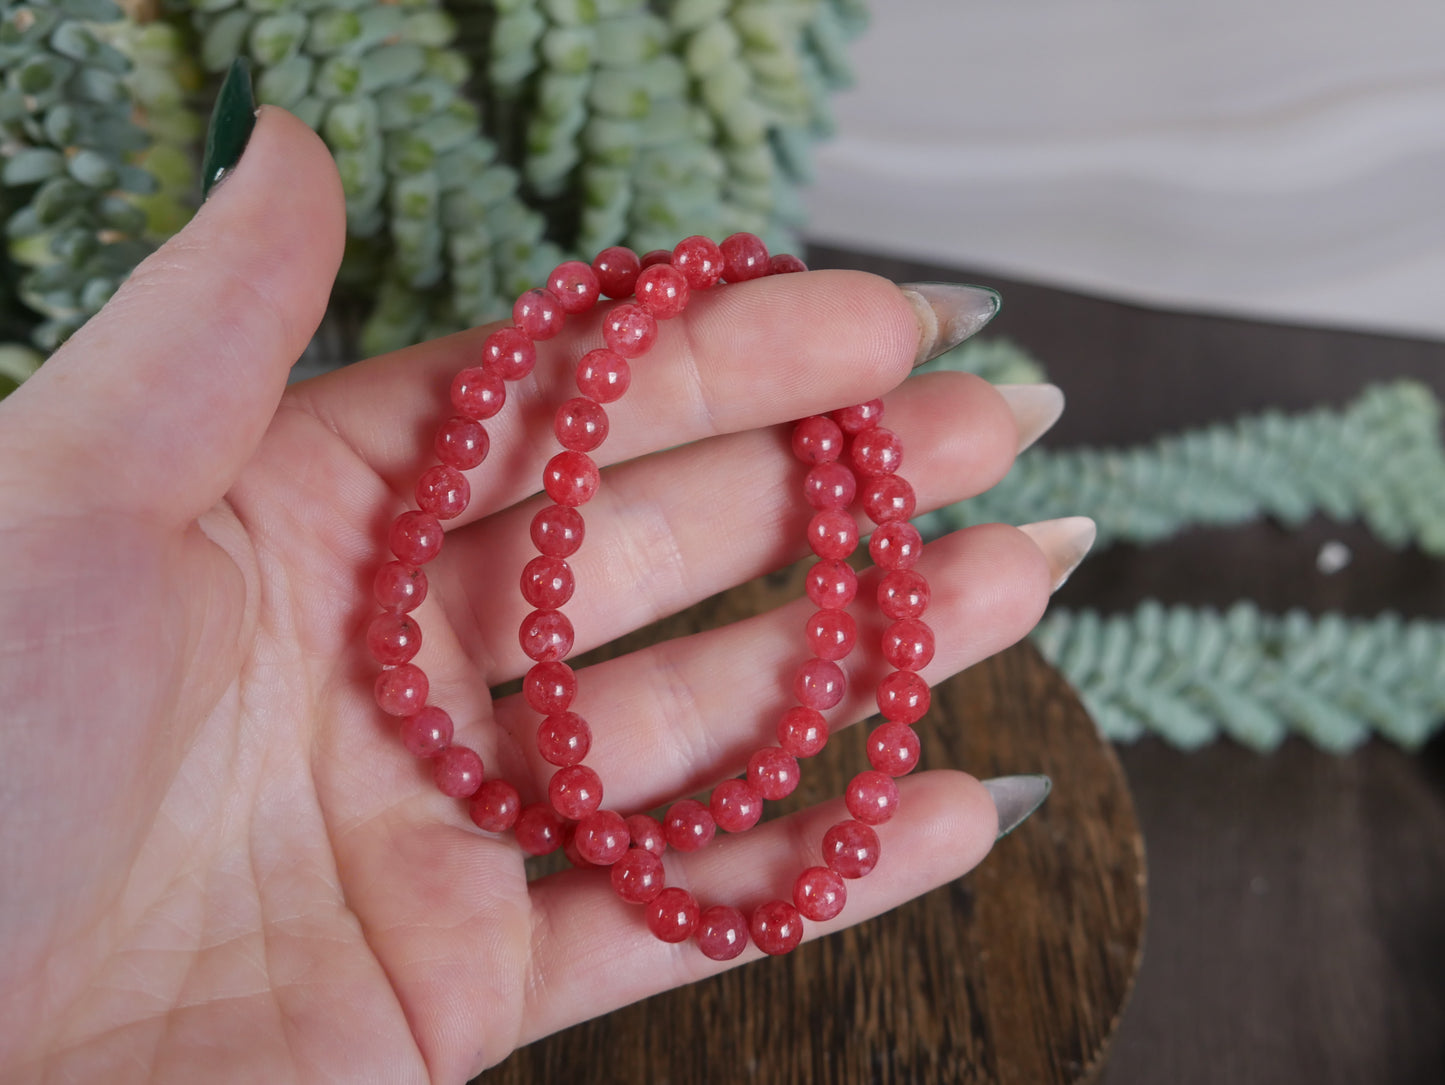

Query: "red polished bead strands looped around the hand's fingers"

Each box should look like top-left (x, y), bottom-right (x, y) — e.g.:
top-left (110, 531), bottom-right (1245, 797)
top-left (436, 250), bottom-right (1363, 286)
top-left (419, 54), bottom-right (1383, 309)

top-left (367, 234), bottom-right (933, 961)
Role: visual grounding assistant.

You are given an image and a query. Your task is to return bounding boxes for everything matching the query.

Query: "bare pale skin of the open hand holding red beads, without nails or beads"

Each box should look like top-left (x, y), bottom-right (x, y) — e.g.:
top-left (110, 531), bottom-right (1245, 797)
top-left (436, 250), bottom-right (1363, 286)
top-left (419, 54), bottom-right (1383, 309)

top-left (0, 110), bottom-right (1051, 1082)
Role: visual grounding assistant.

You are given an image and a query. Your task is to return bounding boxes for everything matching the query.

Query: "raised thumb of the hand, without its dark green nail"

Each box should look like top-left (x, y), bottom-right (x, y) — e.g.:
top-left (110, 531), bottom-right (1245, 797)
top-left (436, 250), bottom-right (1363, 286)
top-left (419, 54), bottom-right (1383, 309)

top-left (0, 108), bottom-right (345, 523)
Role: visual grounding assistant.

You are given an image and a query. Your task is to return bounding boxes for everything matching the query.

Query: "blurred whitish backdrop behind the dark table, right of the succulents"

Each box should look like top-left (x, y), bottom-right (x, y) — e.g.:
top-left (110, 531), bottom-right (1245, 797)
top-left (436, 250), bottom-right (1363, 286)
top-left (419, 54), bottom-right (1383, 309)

top-left (808, 0), bottom-right (1445, 338)
